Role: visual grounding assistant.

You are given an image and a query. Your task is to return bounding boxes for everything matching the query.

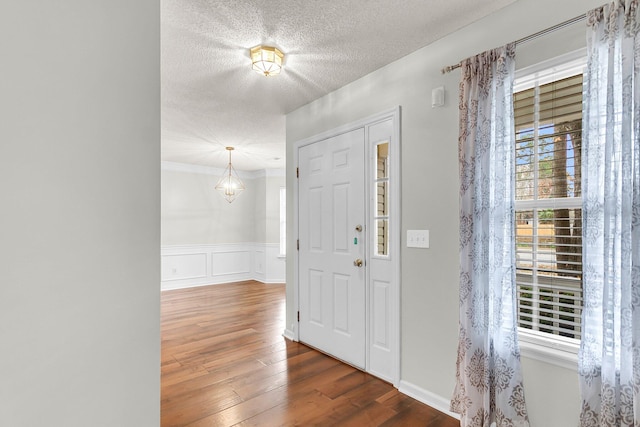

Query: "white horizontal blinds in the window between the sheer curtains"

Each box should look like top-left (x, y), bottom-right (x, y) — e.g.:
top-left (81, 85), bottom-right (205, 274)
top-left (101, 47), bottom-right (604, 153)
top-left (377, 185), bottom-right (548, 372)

top-left (514, 74), bottom-right (582, 339)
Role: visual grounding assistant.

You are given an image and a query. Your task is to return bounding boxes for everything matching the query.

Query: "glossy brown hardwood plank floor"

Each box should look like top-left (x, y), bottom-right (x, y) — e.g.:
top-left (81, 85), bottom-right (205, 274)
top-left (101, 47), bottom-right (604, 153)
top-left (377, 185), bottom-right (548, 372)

top-left (161, 281), bottom-right (459, 427)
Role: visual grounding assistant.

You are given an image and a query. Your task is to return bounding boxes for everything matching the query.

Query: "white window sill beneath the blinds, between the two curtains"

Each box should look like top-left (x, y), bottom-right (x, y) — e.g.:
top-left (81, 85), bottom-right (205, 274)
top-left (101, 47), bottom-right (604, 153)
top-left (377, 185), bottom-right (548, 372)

top-left (518, 329), bottom-right (580, 371)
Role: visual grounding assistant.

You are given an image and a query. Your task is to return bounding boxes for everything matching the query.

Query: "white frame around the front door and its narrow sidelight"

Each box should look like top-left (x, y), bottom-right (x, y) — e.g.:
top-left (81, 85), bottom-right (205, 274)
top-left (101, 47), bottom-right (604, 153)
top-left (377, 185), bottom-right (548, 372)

top-left (292, 106), bottom-right (402, 388)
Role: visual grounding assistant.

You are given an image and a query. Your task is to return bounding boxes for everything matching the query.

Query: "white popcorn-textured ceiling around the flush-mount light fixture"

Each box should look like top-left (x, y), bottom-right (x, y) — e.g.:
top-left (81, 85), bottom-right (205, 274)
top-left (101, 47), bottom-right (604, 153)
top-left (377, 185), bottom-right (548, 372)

top-left (161, 0), bottom-right (515, 170)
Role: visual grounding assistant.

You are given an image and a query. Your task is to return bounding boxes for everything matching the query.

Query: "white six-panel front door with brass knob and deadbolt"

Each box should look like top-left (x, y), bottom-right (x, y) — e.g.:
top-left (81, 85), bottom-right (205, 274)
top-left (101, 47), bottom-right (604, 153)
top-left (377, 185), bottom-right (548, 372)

top-left (298, 128), bottom-right (366, 369)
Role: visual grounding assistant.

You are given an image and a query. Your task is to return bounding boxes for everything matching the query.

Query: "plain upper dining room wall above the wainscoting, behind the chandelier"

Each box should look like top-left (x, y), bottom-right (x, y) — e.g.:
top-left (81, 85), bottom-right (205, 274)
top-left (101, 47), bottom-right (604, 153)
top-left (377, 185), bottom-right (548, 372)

top-left (161, 162), bottom-right (285, 246)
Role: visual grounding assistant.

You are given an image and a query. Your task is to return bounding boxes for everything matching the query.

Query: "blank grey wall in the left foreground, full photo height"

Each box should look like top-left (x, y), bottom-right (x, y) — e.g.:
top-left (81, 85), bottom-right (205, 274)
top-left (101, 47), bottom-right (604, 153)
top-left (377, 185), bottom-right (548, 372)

top-left (0, 0), bottom-right (160, 427)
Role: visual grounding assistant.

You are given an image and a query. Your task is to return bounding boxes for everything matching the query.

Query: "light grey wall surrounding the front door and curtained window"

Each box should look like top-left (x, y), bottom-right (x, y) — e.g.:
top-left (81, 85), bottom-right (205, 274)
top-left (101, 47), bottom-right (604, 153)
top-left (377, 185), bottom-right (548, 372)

top-left (286, 0), bottom-right (601, 427)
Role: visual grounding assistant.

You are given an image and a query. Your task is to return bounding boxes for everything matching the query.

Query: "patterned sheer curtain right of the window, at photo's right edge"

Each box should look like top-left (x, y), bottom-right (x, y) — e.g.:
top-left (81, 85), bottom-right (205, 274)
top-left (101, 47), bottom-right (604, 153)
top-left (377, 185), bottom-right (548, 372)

top-left (579, 0), bottom-right (640, 427)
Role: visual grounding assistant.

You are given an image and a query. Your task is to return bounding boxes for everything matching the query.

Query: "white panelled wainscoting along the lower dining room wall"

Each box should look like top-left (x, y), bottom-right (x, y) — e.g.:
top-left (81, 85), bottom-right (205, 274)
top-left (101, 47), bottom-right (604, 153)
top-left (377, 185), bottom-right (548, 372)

top-left (161, 243), bottom-right (286, 290)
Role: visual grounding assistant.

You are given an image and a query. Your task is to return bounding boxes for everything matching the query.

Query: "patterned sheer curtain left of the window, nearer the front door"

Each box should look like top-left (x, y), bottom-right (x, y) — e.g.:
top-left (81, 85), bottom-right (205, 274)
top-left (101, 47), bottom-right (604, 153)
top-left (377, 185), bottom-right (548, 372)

top-left (451, 44), bottom-right (529, 427)
